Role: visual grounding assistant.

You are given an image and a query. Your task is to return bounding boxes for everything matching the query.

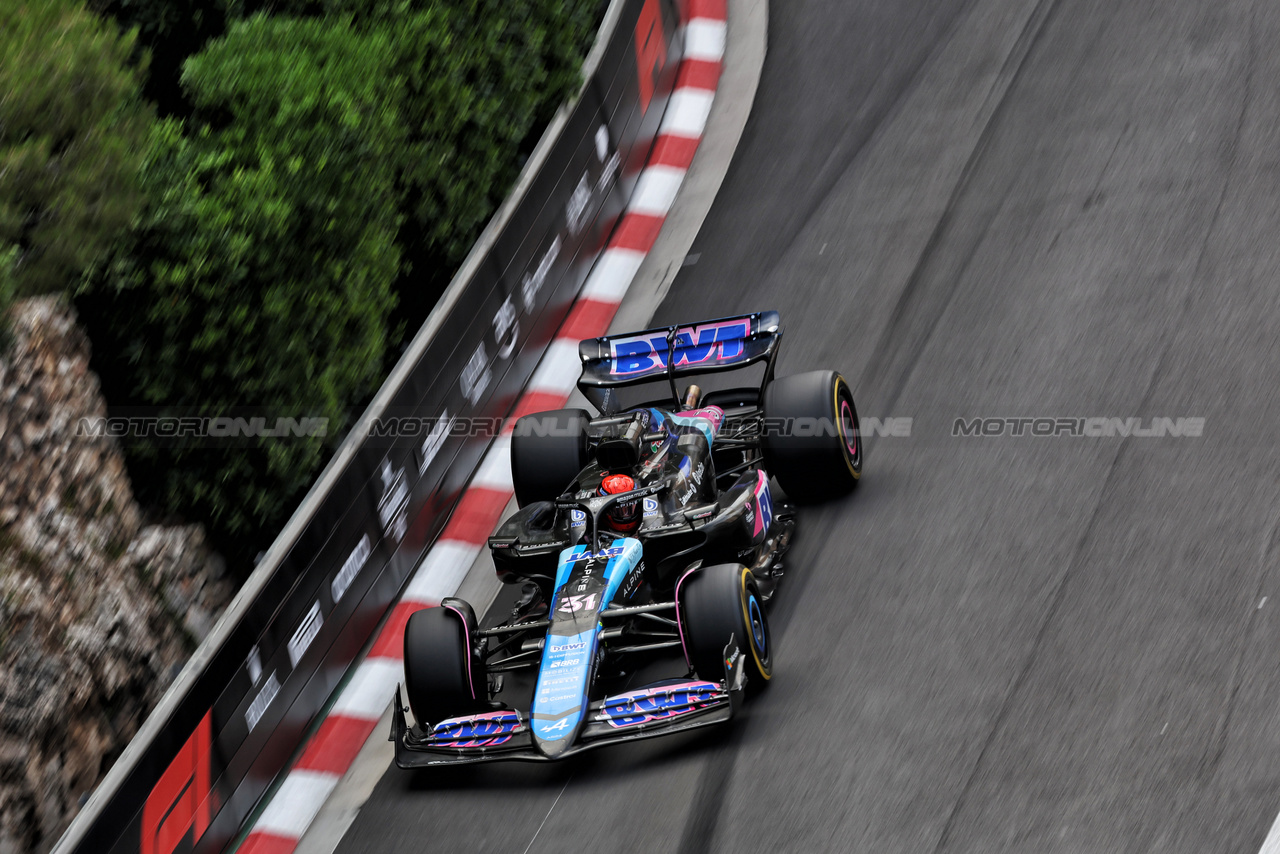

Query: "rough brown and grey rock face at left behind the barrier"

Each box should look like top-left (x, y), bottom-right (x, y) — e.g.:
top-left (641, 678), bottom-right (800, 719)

top-left (0, 298), bottom-right (234, 854)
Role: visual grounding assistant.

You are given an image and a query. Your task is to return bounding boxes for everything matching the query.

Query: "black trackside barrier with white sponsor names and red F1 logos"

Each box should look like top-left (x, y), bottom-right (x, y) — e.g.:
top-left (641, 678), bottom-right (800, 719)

top-left (55, 0), bottom-right (684, 854)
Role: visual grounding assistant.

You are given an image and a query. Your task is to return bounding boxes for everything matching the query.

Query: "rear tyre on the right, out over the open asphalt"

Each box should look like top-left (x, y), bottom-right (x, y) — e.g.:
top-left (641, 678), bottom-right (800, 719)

top-left (764, 371), bottom-right (863, 503)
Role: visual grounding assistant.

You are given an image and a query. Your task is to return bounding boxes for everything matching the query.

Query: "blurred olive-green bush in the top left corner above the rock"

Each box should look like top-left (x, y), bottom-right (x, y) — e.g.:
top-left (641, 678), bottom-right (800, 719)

top-left (0, 0), bottom-right (154, 296)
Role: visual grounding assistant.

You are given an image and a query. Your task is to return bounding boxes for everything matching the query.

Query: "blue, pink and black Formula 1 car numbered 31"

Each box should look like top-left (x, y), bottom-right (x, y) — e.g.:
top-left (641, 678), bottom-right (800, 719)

top-left (392, 311), bottom-right (863, 768)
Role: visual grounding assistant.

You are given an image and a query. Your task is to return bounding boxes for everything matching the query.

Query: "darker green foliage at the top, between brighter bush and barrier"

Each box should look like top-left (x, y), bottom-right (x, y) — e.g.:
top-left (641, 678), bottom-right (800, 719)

top-left (229, 0), bottom-right (600, 271)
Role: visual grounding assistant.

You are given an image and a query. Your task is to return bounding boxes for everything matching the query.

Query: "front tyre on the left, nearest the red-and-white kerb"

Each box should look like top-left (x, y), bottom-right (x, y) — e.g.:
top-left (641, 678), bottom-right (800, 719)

top-left (404, 599), bottom-right (489, 729)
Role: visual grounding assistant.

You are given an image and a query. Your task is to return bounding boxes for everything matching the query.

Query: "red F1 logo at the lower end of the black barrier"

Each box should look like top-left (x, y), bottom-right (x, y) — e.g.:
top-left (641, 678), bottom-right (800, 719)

top-left (141, 712), bottom-right (214, 854)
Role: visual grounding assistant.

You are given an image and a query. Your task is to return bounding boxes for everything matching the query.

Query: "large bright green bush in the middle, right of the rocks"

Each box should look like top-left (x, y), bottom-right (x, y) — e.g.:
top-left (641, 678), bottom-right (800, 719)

top-left (82, 17), bottom-right (403, 543)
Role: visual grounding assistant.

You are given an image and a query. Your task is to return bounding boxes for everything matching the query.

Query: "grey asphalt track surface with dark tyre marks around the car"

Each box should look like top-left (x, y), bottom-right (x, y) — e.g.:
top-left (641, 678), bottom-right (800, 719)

top-left (339, 0), bottom-right (1280, 854)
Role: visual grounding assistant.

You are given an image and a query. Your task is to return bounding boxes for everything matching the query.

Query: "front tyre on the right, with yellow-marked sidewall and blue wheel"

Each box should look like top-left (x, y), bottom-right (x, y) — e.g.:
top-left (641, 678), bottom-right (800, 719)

top-left (676, 563), bottom-right (773, 689)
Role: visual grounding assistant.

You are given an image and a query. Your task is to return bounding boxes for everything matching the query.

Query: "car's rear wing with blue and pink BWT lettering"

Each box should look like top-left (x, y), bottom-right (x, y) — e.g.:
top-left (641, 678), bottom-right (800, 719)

top-left (577, 311), bottom-right (782, 412)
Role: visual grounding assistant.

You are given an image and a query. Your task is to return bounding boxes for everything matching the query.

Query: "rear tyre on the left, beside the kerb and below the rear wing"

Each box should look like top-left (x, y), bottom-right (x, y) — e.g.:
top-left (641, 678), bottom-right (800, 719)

top-left (511, 410), bottom-right (591, 507)
